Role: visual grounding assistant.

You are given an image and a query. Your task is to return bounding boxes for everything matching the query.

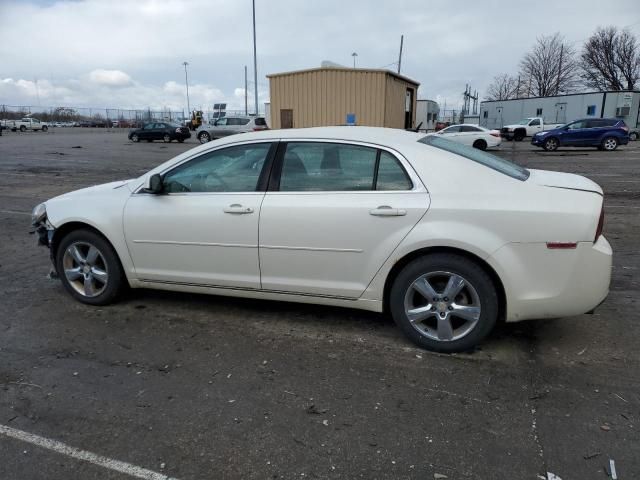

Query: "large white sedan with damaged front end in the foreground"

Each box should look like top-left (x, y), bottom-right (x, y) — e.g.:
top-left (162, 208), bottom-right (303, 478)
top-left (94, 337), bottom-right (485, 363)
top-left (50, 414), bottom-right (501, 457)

top-left (33, 127), bottom-right (612, 352)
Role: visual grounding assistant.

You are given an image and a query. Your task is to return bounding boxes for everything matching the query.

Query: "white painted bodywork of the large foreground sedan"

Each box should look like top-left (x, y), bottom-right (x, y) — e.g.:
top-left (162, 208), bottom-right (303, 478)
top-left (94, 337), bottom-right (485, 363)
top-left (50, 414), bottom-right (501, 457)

top-left (46, 127), bottom-right (612, 321)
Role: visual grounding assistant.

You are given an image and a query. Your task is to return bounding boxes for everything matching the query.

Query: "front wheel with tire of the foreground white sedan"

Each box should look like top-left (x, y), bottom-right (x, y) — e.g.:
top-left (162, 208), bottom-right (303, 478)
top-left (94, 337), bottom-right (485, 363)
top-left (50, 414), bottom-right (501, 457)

top-left (55, 229), bottom-right (125, 305)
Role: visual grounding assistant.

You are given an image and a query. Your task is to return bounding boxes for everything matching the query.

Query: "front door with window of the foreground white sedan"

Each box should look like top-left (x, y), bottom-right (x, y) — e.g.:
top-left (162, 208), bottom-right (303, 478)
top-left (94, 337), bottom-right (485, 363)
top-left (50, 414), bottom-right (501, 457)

top-left (124, 142), bottom-right (275, 289)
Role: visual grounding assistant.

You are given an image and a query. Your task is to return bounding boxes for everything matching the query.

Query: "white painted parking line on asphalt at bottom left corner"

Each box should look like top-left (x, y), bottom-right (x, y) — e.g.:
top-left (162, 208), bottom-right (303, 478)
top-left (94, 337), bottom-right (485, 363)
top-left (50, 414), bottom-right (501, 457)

top-left (0, 425), bottom-right (177, 480)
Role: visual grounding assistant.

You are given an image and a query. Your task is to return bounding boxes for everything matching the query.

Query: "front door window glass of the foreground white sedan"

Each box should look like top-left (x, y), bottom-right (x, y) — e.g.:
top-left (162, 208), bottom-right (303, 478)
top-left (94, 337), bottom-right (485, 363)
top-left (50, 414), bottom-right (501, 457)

top-left (163, 143), bottom-right (271, 193)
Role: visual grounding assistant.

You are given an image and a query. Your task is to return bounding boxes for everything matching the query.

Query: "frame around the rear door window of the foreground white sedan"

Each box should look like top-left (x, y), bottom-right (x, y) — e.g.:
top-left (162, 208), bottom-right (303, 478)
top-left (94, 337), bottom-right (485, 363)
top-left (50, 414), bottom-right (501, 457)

top-left (266, 138), bottom-right (428, 195)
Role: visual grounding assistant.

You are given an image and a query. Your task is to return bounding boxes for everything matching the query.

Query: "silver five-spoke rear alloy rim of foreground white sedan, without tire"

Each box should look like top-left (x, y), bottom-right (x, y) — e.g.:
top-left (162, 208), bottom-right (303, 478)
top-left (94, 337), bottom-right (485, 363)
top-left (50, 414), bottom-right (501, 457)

top-left (404, 271), bottom-right (481, 342)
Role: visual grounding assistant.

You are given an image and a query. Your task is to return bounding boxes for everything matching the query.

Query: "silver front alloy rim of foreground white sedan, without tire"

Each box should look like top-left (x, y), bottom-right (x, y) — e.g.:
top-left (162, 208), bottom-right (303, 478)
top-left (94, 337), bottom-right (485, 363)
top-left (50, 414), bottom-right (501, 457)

top-left (62, 242), bottom-right (109, 297)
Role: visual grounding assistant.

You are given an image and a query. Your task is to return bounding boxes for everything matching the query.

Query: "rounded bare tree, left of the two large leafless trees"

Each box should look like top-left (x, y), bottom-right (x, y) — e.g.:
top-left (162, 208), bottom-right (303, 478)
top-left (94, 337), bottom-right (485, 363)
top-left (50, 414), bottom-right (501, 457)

top-left (520, 33), bottom-right (578, 97)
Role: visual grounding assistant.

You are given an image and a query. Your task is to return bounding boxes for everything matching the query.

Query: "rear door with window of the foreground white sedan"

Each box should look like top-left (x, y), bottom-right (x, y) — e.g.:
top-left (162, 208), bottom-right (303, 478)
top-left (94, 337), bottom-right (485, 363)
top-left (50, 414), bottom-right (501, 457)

top-left (260, 141), bottom-right (429, 298)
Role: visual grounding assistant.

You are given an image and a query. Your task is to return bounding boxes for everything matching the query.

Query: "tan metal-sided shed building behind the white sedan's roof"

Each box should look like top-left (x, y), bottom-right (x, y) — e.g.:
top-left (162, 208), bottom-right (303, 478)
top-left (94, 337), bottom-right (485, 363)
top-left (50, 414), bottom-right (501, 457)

top-left (267, 67), bottom-right (420, 128)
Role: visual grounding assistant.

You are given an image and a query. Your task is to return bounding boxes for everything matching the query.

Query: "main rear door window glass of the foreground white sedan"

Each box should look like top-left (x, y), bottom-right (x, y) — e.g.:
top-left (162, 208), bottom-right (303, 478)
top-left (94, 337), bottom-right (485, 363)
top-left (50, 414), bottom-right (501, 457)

top-left (280, 142), bottom-right (377, 192)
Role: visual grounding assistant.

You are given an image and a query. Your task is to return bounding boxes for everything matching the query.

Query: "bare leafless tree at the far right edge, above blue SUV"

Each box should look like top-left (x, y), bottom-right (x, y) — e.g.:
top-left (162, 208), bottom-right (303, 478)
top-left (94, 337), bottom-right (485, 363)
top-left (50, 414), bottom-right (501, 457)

top-left (580, 27), bottom-right (640, 90)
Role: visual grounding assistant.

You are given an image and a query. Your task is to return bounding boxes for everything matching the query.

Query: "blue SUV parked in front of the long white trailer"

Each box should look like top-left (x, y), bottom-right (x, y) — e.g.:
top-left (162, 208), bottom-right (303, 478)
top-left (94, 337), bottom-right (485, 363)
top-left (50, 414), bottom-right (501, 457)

top-left (531, 118), bottom-right (629, 152)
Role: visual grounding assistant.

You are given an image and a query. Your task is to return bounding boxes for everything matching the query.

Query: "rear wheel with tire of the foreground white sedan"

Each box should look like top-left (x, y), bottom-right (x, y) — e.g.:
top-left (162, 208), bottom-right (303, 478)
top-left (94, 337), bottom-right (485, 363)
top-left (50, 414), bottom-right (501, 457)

top-left (389, 253), bottom-right (498, 353)
